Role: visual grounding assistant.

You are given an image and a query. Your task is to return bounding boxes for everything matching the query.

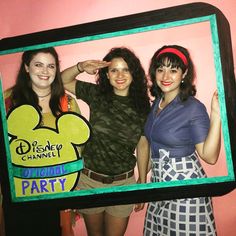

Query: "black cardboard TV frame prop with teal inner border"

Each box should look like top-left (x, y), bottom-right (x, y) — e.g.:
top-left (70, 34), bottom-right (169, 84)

top-left (0, 3), bottom-right (236, 209)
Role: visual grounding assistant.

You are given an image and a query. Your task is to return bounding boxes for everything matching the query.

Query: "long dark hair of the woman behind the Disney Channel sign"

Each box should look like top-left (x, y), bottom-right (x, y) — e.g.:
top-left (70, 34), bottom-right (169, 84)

top-left (11, 47), bottom-right (65, 116)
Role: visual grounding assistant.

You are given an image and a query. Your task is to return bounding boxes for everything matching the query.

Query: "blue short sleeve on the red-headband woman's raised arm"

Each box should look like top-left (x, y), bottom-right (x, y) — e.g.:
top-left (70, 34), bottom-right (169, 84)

top-left (190, 102), bottom-right (210, 144)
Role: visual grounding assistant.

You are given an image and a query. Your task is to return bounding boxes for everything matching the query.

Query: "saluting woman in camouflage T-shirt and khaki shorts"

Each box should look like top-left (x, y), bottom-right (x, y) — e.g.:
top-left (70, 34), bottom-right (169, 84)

top-left (62, 47), bottom-right (150, 236)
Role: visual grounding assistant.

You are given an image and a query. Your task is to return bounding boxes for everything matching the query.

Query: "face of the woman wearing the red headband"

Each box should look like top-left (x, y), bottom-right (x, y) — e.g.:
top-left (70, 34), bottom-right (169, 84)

top-left (156, 61), bottom-right (187, 97)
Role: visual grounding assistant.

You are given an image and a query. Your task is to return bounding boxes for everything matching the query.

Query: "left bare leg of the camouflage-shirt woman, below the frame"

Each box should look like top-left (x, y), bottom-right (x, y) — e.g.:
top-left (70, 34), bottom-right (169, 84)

top-left (83, 212), bottom-right (104, 236)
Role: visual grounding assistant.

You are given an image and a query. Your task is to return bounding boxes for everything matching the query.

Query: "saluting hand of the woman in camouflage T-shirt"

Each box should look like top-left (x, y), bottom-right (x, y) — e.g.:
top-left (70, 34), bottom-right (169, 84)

top-left (77, 60), bottom-right (110, 75)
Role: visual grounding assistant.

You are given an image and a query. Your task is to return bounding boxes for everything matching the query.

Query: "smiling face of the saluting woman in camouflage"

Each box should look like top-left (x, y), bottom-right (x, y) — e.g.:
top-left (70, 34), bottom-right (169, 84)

top-left (107, 58), bottom-right (133, 96)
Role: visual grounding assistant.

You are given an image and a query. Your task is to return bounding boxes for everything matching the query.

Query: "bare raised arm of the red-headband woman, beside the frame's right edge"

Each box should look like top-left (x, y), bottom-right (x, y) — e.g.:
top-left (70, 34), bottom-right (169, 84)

top-left (196, 92), bottom-right (221, 165)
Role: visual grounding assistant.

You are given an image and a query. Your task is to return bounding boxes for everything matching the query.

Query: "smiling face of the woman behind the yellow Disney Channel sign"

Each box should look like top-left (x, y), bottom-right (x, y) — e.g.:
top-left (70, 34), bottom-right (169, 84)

top-left (25, 53), bottom-right (56, 91)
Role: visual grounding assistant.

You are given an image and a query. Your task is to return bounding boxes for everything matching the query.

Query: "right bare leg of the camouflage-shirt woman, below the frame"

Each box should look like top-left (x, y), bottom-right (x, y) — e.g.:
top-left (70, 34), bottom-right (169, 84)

top-left (105, 213), bottom-right (129, 236)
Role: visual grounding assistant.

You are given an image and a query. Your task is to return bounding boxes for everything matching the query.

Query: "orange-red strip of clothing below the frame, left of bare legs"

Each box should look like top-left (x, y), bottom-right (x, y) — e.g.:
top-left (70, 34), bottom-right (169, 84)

top-left (60, 211), bottom-right (74, 236)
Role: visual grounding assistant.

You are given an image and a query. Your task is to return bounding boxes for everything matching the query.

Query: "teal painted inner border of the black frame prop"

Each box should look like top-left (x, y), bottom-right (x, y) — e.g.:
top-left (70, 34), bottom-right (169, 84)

top-left (0, 14), bottom-right (235, 202)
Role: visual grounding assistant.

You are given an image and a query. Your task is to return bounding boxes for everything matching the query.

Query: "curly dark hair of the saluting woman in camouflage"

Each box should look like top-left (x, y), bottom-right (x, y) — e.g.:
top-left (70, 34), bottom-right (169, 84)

top-left (97, 47), bottom-right (150, 114)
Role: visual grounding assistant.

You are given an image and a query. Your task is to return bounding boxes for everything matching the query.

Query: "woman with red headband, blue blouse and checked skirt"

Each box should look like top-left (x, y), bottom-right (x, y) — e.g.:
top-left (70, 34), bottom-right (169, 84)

top-left (144, 45), bottom-right (221, 236)
